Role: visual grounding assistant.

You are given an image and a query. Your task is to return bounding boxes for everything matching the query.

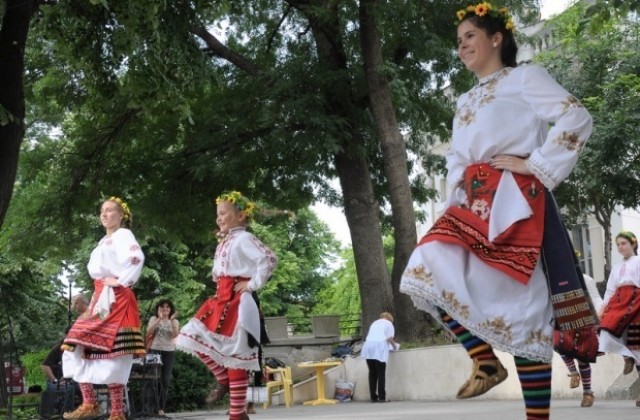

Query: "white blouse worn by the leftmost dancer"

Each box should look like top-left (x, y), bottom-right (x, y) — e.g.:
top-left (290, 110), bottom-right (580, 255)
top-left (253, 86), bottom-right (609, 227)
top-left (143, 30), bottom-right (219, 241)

top-left (87, 228), bottom-right (144, 287)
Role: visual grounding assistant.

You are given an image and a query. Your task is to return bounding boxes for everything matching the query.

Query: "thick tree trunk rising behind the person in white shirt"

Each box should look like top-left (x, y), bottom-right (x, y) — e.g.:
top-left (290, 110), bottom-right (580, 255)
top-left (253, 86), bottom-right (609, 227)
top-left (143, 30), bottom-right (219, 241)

top-left (290, 2), bottom-right (394, 328)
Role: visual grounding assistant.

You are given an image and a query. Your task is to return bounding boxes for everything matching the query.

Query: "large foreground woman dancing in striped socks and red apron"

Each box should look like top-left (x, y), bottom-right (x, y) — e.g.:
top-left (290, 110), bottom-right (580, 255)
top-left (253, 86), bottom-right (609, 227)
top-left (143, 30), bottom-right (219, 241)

top-left (400, 2), bottom-right (597, 419)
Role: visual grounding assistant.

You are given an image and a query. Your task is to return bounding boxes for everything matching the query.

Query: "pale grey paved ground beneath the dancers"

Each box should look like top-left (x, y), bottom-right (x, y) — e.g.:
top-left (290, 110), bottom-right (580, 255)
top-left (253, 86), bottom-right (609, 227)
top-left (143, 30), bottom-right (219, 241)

top-left (159, 400), bottom-right (640, 420)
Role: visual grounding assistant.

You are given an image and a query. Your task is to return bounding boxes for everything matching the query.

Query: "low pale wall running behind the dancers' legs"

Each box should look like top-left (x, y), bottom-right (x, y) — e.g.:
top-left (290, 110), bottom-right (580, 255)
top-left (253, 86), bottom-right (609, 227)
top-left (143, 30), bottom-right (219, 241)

top-left (273, 345), bottom-right (638, 404)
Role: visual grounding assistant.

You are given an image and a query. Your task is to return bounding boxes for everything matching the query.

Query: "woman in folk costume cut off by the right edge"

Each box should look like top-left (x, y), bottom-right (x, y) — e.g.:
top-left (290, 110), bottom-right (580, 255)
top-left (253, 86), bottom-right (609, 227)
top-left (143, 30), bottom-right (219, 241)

top-left (599, 231), bottom-right (640, 407)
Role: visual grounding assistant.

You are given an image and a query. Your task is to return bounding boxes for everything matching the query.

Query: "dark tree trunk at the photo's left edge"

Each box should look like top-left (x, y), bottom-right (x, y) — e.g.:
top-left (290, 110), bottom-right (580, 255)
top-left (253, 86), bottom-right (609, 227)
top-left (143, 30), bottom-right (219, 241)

top-left (0, 0), bottom-right (37, 227)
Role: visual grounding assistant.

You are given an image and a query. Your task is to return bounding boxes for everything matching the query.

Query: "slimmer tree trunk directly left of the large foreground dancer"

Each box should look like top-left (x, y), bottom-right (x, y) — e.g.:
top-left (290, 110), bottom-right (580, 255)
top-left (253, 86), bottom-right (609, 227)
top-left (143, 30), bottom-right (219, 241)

top-left (360, 0), bottom-right (431, 341)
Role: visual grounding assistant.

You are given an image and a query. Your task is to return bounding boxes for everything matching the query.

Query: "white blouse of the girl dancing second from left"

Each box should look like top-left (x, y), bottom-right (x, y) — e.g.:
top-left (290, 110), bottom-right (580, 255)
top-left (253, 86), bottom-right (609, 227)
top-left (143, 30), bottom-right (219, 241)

top-left (212, 227), bottom-right (278, 291)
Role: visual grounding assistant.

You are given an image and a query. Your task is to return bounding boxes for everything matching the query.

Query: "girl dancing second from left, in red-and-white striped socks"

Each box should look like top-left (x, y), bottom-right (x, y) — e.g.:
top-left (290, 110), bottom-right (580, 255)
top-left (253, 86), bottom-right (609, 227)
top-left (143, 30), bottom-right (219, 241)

top-left (176, 191), bottom-right (278, 420)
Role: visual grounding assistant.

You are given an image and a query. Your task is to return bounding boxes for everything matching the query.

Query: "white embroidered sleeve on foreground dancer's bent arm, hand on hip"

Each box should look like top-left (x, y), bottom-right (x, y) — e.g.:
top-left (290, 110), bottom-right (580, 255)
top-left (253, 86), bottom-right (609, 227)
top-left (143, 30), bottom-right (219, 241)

top-left (521, 65), bottom-right (592, 189)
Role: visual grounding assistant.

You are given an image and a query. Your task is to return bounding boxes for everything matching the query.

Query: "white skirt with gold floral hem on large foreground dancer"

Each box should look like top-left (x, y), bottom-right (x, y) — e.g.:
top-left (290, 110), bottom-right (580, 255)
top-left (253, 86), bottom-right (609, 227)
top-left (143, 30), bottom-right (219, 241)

top-left (400, 241), bottom-right (553, 363)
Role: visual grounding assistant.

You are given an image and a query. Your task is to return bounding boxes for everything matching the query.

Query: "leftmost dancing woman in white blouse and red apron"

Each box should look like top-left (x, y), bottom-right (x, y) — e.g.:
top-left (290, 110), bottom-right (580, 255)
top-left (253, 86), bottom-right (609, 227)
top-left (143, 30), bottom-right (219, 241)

top-left (62, 197), bottom-right (145, 420)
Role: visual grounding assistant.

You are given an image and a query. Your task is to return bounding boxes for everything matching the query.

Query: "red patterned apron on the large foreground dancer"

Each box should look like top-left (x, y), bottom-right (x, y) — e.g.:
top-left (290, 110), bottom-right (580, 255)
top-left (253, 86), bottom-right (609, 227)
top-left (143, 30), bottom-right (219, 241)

top-left (418, 163), bottom-right (545, 284)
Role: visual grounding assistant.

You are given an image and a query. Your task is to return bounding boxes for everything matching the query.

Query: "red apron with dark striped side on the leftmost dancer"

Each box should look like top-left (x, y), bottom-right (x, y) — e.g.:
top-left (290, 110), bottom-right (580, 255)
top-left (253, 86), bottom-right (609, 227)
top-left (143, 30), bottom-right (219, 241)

top-left (62, 279), bottom-right (145, 359)
